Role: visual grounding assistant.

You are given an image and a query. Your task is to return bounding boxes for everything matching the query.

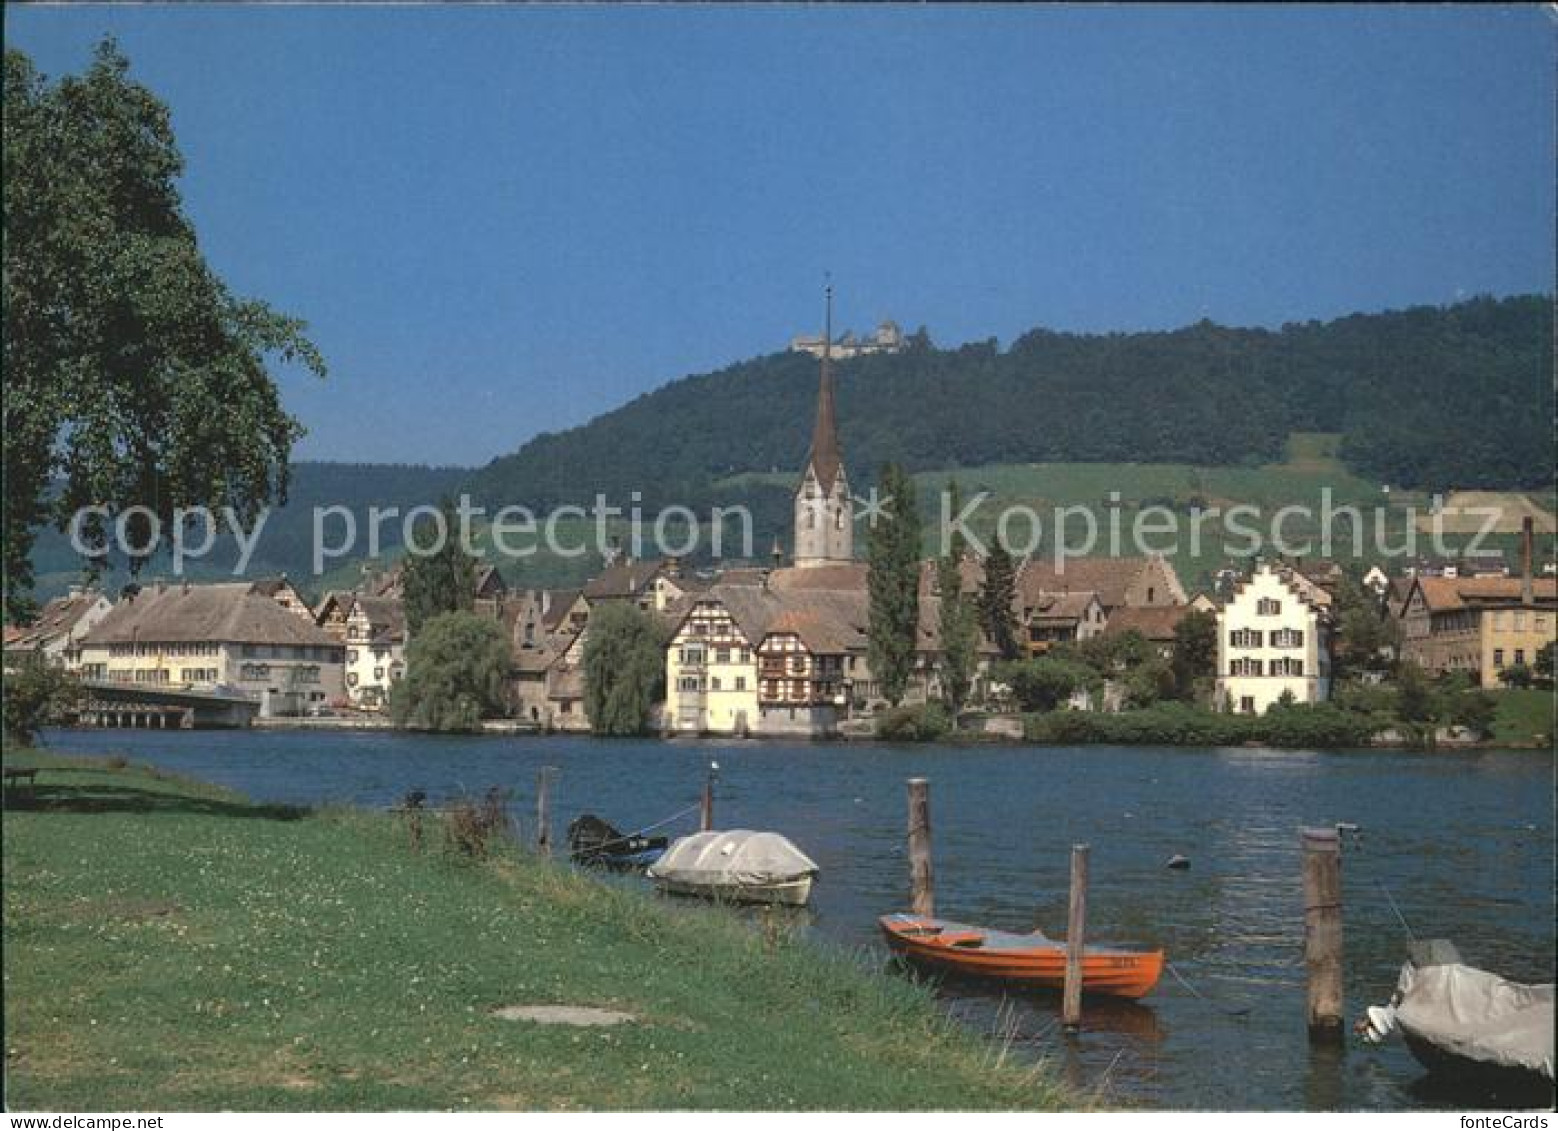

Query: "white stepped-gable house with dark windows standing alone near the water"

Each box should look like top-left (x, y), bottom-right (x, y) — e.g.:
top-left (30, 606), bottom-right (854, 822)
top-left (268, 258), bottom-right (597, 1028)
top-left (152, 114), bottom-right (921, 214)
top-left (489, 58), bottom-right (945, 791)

top-left (1217, 562), bottom-right (1331, 713)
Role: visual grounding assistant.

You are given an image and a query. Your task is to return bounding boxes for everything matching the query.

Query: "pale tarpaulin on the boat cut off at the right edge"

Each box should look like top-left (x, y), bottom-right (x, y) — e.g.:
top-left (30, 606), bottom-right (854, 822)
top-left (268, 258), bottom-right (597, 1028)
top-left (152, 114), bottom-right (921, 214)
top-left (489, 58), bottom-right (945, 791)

top-left (1396, 963), bottom-right (1553, 1080)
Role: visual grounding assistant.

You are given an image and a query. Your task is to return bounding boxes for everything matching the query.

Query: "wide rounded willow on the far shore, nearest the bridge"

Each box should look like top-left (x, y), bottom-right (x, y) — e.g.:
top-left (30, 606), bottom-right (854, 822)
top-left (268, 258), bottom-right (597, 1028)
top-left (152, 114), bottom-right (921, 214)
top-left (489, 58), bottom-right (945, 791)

top-left (390, 612), bottom-right (509, 731)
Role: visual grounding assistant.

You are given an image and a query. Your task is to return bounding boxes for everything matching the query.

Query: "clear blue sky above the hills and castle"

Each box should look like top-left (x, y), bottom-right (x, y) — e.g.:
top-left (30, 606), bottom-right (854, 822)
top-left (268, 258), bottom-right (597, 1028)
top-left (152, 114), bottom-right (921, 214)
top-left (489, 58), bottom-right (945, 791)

top-left (5, 5), bottom-right (1555, 464)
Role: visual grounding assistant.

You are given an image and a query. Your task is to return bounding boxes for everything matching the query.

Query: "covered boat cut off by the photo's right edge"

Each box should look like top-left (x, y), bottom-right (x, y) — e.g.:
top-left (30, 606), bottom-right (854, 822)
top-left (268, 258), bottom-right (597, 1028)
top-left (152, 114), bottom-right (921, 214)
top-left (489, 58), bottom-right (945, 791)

top-left (1357, 939), bottom-right (1553, 1090)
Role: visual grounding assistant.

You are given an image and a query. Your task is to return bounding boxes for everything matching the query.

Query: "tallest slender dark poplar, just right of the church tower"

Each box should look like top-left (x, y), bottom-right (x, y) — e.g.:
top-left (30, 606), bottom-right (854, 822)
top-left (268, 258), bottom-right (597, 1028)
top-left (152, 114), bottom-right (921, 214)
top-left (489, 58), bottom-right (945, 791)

top-left (866, 463), bottom-right (921, 707)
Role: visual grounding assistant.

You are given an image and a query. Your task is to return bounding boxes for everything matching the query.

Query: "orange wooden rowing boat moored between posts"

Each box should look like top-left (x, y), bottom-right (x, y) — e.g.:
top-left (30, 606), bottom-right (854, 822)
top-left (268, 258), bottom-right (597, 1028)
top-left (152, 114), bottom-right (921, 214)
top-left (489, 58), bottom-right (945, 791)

top-left (879, 914), bottom-right (1164, 997)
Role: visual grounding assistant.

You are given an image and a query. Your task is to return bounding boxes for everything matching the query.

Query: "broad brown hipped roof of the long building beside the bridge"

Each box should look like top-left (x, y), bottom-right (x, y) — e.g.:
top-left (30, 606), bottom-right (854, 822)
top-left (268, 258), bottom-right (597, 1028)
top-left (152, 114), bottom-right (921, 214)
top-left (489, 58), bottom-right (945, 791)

top-left (84, 581), bottom-right (340, 647)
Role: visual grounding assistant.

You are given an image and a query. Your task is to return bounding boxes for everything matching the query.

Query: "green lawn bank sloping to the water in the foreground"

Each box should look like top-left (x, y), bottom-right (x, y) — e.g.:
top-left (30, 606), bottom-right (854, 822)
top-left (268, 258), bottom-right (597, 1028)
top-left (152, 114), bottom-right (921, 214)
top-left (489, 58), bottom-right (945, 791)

top-left (5, 752), bottom-right (1063, 1111)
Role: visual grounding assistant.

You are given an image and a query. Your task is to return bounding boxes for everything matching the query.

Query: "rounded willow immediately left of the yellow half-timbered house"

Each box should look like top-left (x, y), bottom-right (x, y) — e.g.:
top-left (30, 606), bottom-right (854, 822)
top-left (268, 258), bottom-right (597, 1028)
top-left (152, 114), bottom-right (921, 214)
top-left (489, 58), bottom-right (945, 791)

top-left (583, 601), bottom-right (670, 735)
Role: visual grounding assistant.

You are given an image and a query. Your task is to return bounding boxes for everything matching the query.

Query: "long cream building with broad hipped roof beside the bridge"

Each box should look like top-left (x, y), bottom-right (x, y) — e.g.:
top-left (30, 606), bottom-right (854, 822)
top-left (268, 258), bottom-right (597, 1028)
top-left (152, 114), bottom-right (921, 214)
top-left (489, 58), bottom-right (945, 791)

top-left (81, 583), bottom-right (346, 715)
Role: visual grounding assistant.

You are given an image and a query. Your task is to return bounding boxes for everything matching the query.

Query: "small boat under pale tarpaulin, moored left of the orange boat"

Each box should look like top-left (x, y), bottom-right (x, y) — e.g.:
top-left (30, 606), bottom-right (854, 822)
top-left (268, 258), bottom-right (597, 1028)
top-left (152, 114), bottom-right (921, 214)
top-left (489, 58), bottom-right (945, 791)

top-left (648, 829), bottom-right (821, 907)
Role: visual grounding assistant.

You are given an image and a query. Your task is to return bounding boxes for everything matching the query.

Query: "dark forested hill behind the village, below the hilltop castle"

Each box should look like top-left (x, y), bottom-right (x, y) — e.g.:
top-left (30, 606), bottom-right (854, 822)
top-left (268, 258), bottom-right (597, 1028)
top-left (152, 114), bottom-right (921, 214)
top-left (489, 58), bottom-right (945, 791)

top-left (471, 296), bottom-right (1553, 506)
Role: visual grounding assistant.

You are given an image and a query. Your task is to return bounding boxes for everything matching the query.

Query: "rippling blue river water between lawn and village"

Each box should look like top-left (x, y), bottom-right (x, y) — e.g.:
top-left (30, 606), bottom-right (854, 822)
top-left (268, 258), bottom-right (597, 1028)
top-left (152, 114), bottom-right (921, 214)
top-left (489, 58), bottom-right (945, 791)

top-left (33, 731), bottom-right (1555, 1109)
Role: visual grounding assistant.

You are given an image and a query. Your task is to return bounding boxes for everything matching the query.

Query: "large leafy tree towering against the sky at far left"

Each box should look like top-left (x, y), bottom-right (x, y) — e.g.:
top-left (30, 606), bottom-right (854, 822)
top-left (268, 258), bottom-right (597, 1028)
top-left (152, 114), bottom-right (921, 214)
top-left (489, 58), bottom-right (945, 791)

top-left (3, 39), bottom-right (326, 611)
